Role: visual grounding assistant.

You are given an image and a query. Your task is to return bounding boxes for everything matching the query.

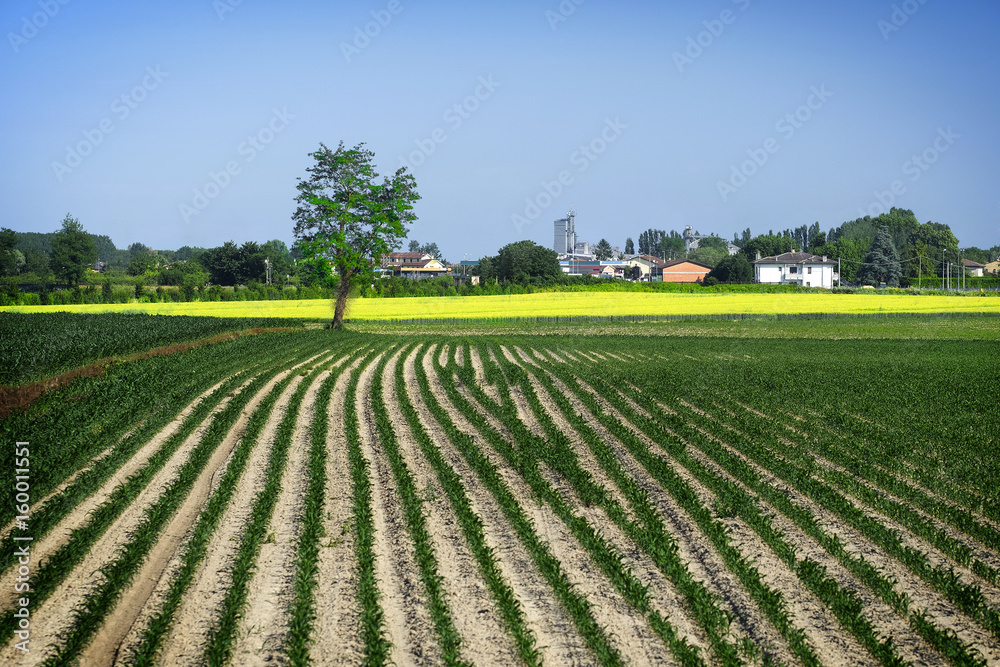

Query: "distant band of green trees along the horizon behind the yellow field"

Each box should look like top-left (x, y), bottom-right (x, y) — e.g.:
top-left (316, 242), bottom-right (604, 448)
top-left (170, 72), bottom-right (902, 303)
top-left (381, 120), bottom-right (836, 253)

top-left (0, 208), bottom-right (1000, 288)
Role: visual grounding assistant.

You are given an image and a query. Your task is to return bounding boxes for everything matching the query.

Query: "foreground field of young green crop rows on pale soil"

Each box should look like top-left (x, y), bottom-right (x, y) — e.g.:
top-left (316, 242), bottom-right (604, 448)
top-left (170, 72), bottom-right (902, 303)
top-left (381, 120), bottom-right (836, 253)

top-left (0, 320), bottom-right (1000, 666)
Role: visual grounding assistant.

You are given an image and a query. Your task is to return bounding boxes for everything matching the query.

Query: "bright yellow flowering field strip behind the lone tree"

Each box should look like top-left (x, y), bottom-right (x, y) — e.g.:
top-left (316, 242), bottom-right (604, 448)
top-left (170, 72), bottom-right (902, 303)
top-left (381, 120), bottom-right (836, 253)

top-left (0, 292), bottom-right (1000, 320)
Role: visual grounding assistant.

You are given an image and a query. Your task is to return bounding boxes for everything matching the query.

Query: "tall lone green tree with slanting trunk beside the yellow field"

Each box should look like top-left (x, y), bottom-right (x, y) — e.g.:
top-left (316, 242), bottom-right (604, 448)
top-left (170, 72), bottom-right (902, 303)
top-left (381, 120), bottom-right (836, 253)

top-left (292, 141), bottom-right (420, 329)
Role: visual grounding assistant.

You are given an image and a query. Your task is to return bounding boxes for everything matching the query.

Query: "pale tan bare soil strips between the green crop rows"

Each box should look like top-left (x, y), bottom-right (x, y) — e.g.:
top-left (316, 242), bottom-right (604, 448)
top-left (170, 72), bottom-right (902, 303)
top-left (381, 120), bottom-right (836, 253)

top-left (9, 342), bottom-right (1000, 666)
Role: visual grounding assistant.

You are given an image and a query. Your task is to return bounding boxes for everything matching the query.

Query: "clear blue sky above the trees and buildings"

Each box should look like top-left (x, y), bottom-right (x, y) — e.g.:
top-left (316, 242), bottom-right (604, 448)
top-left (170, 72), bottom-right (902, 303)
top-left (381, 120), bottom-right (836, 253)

top-left (0, 0), bottom-right (1000, 261)
